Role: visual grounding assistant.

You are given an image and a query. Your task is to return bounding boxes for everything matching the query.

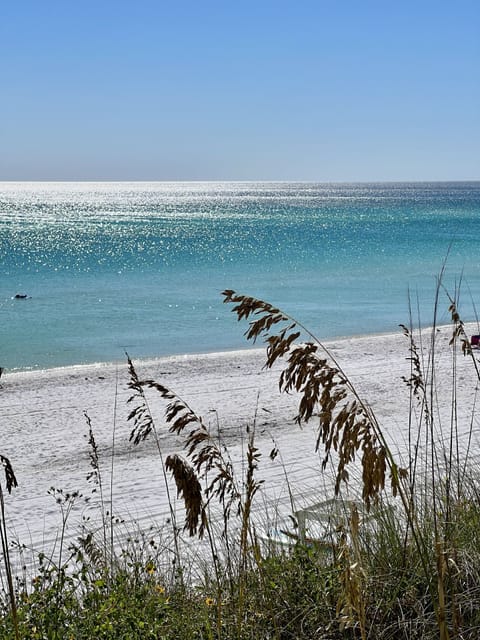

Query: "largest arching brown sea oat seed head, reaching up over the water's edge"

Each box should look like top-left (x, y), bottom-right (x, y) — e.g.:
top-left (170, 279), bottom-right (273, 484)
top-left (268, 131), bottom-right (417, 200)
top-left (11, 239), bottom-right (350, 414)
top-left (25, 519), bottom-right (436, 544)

top-left (222, 289), bottom-right (406, 508)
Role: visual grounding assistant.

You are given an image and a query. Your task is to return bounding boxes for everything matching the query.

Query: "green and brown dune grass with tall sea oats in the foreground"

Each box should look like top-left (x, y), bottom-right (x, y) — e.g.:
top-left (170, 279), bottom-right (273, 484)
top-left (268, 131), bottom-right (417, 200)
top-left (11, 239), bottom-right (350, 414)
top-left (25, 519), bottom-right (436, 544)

top-left (0, 291), bottom-right (480, 640)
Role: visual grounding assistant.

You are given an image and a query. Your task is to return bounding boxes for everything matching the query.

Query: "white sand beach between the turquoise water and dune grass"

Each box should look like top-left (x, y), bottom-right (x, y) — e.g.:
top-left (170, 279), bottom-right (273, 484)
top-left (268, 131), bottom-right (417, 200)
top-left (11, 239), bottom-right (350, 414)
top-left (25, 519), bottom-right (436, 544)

top-left (0, 326), bottom-right (480, 564)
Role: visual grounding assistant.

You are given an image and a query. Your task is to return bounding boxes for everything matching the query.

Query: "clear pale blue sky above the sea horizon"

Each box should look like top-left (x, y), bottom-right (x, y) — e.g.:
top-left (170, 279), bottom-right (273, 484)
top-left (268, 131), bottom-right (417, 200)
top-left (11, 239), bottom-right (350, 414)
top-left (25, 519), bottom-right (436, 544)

top-left (0, 0), bottom-right (480, 181)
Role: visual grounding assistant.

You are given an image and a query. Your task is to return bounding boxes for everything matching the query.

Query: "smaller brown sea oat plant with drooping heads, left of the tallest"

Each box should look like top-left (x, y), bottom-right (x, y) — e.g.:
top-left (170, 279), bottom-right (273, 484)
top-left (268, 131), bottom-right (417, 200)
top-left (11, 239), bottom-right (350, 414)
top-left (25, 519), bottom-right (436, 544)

top-left (125, 359), bottom-right (268, 633)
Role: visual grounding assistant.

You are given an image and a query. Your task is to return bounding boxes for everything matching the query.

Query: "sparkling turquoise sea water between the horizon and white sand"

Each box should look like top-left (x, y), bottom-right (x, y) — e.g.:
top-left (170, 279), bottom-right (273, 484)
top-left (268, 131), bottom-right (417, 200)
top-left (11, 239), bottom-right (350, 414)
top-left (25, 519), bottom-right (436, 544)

top-left (0, 182), bottom-right (480, 369)
